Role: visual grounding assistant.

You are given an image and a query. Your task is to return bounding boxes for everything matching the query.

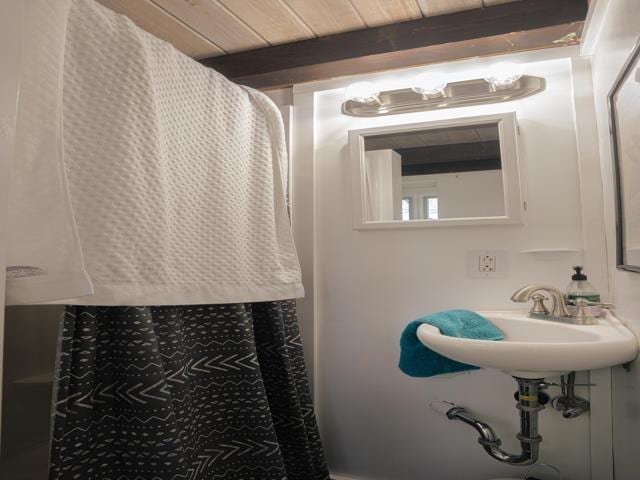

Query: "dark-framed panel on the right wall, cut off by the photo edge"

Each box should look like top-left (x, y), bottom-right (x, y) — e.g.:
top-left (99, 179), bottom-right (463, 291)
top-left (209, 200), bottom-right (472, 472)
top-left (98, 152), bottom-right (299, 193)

top-left (609, 43), bottom-right (640, 272)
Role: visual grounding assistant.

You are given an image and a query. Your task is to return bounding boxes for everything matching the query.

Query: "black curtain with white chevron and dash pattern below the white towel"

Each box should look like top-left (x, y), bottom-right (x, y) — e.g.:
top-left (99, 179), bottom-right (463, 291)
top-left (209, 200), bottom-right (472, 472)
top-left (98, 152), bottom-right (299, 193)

top-left (49, 300), bottom-right (329, 480)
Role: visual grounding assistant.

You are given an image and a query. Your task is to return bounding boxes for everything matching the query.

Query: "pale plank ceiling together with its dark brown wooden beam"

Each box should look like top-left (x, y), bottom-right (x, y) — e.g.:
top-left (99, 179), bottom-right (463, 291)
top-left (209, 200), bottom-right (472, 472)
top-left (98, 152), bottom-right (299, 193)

top-left (98, 0), bottom-right (588, 89)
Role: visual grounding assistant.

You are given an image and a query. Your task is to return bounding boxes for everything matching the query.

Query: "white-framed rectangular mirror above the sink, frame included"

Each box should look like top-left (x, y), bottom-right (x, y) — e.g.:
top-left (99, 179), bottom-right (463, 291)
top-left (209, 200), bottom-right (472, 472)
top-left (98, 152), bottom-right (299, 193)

top-left (349, 113), bottom-right (522, 229)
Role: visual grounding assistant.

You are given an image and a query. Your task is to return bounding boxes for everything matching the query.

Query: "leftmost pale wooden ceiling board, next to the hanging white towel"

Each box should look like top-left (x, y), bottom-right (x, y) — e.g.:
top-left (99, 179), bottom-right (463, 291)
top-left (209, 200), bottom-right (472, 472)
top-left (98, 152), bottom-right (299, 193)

top-left (98, 0), bottom-right (224, 58)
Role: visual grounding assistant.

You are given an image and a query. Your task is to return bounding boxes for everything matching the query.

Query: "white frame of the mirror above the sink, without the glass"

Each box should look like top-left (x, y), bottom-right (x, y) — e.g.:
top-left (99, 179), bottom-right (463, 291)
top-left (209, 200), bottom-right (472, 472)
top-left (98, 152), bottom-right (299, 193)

top-left (349, 112), bottom-right (524, 230)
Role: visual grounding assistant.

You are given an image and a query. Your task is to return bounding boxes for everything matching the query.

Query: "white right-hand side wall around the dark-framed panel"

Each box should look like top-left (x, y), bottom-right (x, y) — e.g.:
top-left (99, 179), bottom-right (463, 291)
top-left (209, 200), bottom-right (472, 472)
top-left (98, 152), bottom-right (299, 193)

top-left (584, 0), bottom-right (640, 480)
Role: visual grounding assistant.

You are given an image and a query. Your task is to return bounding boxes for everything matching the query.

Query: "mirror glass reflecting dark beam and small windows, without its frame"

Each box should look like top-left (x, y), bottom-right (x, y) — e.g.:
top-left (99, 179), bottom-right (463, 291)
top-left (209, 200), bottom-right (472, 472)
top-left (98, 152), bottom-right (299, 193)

top-left (364, 121), bottom-right (506, 222)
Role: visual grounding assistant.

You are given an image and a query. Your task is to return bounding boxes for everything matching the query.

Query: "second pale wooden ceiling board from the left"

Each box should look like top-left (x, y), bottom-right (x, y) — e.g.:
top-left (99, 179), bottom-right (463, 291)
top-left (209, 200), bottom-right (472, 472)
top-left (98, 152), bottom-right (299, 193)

top-left (152, 0), bottom-right (269, 53)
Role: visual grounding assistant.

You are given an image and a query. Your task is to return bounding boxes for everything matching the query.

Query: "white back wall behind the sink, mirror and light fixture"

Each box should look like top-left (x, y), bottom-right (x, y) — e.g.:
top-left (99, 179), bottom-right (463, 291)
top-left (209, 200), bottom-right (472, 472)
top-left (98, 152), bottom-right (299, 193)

top-left (294, 50), bottom-right (608, 480)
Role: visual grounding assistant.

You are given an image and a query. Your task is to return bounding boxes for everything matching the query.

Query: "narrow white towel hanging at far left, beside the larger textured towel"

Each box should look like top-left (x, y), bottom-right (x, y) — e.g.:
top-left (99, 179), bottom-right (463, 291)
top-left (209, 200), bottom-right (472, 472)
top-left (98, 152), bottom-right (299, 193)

top-left (7, 0), bottom-right (92, 304)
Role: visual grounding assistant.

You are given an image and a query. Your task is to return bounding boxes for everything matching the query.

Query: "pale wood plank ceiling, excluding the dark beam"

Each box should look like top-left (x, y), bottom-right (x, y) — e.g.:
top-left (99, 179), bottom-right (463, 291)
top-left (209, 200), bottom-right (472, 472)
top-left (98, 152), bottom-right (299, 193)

top-left (98, 0), bottom-right (518, 59)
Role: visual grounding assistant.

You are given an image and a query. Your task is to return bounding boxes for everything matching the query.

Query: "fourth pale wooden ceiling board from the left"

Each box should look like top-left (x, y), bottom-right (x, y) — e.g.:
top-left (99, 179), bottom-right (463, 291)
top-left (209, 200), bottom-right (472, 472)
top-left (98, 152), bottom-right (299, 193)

top-left (283, 0), bottom-right (367, 36)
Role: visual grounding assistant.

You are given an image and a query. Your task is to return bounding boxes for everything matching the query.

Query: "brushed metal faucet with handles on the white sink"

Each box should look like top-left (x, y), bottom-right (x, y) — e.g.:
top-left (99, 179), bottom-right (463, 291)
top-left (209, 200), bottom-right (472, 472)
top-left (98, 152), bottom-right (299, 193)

top-left (511, 285), bottom-right (598, 325)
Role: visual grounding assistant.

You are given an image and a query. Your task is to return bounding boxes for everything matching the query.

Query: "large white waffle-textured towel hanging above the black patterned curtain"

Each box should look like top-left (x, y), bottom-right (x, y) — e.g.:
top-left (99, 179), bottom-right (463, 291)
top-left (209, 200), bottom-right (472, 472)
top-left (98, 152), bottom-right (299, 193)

top-left (9, 0), bottom-right (303, 305)
